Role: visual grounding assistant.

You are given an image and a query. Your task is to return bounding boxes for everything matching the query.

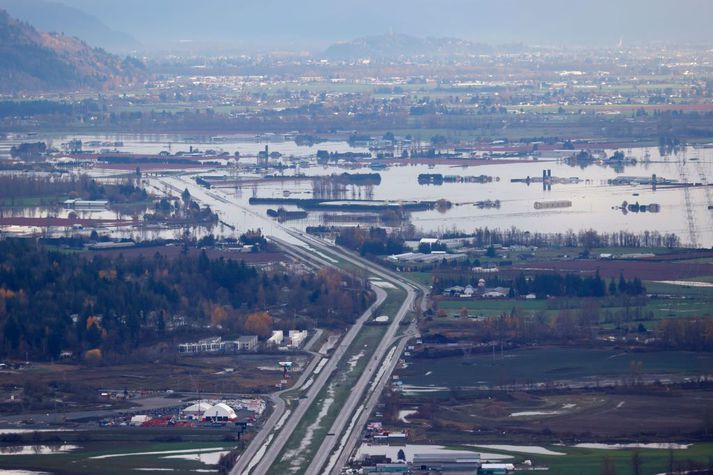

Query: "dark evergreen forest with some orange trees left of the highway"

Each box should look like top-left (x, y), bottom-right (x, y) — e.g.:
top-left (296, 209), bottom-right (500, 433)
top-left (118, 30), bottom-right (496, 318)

top-left (0, 239), bottom-right (372, 359)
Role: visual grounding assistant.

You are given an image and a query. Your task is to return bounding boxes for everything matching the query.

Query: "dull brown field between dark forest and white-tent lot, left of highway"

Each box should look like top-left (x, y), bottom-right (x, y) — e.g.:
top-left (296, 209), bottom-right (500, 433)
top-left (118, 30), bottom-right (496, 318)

top-left (0, 355), bottom-right (296, 416)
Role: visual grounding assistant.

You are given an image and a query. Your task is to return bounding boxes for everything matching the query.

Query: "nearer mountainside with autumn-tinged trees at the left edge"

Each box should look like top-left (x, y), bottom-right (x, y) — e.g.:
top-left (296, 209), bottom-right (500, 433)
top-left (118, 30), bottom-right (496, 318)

top-left (0, 10), bottom-right (144, 92)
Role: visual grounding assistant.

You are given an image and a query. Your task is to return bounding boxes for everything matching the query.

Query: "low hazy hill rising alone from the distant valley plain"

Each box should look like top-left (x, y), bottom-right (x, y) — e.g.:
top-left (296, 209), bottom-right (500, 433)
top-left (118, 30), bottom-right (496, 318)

top-left (322, 34), bottom-right (517, 61)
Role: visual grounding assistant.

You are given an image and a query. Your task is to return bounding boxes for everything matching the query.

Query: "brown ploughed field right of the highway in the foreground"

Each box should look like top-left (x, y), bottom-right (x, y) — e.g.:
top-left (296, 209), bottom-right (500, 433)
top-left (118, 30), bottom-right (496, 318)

top-left (404, 389), bottom-right (713, 442)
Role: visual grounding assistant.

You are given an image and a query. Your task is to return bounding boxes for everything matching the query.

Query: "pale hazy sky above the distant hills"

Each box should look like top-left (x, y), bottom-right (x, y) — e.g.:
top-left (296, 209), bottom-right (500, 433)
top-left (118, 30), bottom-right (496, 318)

top-left (15, 0), bottom-right (713, 48)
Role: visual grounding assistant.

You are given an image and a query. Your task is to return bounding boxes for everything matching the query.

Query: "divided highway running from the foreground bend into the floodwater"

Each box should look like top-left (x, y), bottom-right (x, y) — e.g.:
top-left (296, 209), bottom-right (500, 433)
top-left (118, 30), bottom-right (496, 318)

top-left (154, 177), bottom-right (425, 475)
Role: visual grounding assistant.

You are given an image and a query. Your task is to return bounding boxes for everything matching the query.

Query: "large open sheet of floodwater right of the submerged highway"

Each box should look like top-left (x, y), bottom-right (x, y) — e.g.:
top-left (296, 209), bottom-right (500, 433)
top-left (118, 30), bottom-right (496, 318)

top-left (214, 145), bottom-right (713, 247)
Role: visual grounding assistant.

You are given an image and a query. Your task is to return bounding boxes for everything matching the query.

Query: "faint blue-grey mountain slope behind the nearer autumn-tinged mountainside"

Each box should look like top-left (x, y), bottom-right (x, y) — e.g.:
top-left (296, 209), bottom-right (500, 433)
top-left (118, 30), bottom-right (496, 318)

top-left (0, 0), bottom-right (141, 52)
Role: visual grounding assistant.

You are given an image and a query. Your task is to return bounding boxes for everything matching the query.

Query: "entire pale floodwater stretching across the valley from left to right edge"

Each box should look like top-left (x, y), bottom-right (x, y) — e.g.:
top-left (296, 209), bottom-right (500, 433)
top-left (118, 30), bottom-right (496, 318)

top-left (0, 135), bottom-right (713, 247)
